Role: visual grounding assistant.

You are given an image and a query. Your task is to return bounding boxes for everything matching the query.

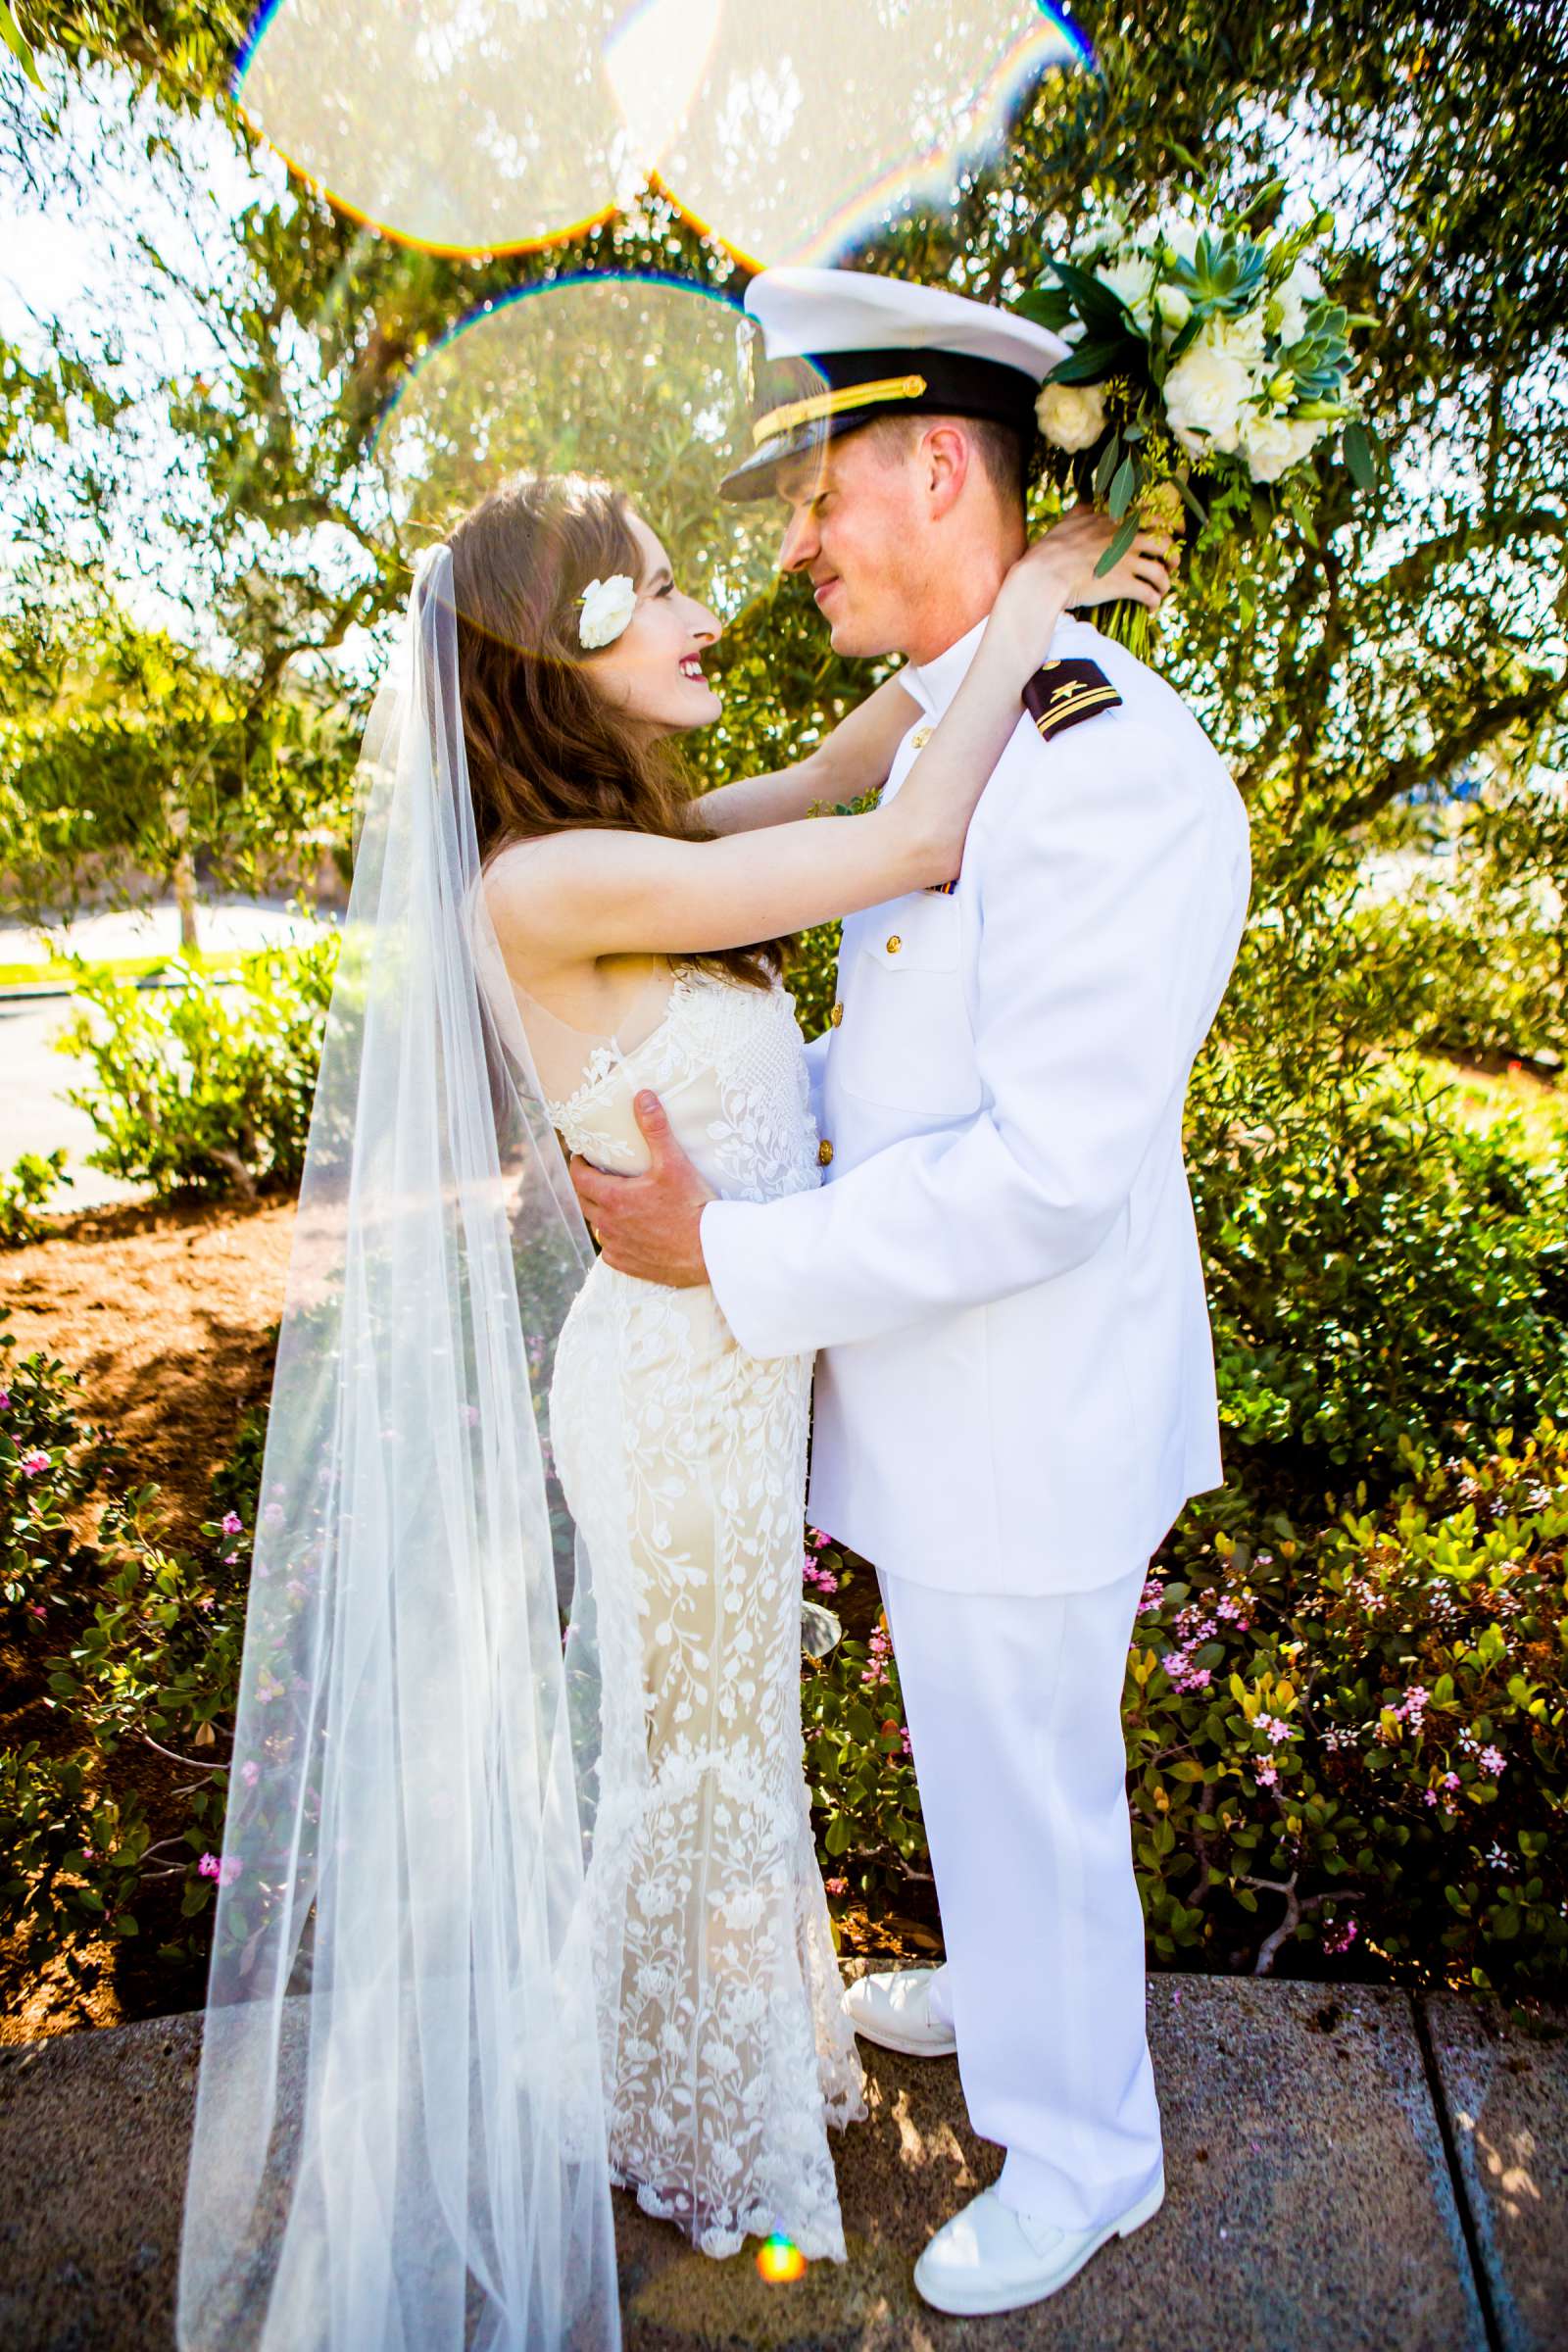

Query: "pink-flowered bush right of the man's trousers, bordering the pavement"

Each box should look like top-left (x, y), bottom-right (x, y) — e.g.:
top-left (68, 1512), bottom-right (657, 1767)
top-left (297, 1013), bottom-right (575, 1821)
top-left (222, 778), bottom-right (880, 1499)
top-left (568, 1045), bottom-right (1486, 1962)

top-left (1126, 1423), bottom-right (1568, 1989)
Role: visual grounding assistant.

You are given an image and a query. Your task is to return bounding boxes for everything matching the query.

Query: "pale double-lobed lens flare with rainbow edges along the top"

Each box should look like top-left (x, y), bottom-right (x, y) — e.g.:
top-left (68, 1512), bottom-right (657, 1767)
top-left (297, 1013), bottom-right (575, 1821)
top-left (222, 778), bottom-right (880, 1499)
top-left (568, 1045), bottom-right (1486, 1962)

top-left (232, 0), bottom-right (1091, 266)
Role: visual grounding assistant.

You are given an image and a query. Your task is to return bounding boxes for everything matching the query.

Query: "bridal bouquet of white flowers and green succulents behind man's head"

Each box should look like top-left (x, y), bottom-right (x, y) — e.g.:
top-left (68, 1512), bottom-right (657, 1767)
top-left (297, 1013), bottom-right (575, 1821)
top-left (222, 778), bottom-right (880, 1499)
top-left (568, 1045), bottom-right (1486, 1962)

top-left (1015, 183), bottom-right (1373, 652)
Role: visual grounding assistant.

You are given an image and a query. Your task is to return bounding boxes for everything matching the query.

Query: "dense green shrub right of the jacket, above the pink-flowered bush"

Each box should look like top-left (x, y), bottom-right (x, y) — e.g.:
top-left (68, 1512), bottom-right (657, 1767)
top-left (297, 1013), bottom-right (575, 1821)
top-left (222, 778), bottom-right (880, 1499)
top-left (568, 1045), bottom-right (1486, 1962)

top-left (1187, 1068), bottom-right (1568, 1507)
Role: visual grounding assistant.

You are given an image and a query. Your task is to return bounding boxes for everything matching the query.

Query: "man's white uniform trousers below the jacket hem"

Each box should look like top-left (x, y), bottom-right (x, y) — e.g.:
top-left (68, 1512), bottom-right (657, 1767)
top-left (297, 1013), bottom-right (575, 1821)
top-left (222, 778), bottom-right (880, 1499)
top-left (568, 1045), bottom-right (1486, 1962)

top-left (877, 1564), bottom-right (1163, 2230)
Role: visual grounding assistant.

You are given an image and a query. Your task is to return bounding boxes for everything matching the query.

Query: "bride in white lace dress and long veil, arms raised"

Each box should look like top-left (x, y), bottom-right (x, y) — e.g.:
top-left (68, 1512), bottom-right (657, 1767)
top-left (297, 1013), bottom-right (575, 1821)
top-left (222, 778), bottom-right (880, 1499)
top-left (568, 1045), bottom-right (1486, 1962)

top-left (176, 475), bottom-right (1170, 2352)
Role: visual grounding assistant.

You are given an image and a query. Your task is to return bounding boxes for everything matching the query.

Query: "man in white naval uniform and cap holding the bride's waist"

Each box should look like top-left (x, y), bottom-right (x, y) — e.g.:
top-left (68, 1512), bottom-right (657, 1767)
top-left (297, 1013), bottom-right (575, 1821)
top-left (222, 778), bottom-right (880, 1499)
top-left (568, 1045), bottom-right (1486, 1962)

top-left (571, 269), bottom-right (1249, 2312)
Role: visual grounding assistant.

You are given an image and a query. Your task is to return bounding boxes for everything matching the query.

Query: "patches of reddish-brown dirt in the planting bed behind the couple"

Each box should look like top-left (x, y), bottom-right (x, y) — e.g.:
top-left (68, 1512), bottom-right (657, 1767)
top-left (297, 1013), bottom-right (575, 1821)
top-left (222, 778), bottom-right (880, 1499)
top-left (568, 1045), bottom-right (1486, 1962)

top-left (0, 1201), bottom-right (941, 2044)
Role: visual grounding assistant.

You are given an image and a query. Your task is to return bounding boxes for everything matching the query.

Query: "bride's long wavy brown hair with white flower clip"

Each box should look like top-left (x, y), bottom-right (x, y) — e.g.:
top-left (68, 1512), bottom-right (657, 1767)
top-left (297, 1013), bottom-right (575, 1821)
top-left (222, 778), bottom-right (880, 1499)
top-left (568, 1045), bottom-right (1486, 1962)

top-left (447, 472), bottom-right (785, 988)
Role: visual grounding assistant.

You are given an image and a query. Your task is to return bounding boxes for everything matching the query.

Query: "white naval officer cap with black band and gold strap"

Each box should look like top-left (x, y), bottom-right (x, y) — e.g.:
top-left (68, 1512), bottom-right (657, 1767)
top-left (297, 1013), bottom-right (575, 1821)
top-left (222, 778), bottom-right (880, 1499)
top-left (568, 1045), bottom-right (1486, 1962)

top-left (719, 264), bottom-right (1069, 501)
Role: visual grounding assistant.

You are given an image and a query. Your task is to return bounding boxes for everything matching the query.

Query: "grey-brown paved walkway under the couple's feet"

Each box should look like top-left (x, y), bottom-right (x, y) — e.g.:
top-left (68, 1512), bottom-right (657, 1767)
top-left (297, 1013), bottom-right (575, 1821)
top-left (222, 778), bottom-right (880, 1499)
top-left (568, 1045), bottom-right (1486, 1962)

top-left (0, 1962), bottom-right (1568, 2352)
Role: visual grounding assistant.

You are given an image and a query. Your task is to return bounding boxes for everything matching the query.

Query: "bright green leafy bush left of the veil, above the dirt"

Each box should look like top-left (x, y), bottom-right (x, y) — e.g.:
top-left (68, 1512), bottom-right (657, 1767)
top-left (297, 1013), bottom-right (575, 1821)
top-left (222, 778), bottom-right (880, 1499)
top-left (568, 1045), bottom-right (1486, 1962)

top-left (59, 934), bottom-right (338, 1198)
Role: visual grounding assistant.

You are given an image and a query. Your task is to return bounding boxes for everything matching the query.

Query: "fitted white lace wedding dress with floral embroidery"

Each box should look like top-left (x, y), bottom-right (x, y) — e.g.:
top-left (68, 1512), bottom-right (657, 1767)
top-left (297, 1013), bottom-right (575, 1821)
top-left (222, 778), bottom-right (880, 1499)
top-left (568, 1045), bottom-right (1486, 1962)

top-left (519, 969), bottom-right (865, 2260)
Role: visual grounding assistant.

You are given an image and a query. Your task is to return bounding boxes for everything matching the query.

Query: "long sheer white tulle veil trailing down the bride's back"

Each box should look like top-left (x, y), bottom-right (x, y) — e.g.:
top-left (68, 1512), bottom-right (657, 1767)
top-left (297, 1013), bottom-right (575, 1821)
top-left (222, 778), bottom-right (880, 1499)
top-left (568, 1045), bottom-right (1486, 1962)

top-left (176, 546), bottom-right (620, 2352)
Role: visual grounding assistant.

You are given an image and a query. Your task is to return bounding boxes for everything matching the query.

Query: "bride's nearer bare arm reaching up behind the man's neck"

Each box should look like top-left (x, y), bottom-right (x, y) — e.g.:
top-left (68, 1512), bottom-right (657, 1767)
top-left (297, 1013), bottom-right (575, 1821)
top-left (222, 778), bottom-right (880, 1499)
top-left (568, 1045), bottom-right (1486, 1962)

top-left (487, 513), bottom-right (1163, 962)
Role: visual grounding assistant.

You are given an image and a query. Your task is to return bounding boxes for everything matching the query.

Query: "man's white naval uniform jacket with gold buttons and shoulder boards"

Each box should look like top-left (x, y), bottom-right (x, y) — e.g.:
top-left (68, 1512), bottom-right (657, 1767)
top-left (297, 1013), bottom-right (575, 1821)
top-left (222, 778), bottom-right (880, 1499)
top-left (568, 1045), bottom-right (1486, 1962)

top-left (701, 621), bottom-right (1250, 1592)
